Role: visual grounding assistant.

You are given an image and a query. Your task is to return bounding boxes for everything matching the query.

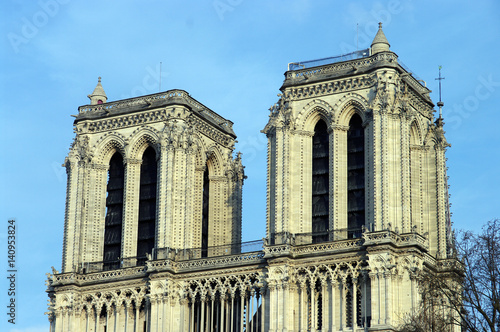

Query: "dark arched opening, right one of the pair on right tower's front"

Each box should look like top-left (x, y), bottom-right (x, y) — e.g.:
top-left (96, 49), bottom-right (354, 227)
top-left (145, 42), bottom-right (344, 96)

top-left (347, 114), bottom-right (365, 238)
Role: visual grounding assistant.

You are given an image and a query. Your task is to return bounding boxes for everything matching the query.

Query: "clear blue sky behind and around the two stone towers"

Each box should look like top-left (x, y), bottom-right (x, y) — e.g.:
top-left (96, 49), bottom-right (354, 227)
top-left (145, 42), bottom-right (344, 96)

top-left (0, 0), bottom-right (500, 332)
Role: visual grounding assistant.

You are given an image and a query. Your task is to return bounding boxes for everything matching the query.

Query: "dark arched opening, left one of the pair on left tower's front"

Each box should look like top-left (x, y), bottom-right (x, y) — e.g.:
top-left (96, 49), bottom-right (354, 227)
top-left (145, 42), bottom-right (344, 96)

top-left (103, 152), bottom-right (125, 270)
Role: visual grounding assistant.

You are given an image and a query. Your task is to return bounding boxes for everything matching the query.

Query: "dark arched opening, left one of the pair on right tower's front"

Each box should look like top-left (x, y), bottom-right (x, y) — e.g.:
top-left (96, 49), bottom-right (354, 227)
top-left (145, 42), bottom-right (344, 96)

top-left (312, 120), bottom-right (329, 243)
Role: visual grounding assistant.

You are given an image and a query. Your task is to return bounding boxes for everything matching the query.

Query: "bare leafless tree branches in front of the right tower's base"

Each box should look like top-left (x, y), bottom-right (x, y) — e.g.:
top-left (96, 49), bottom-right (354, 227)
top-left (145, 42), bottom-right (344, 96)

top-left (398, 219), bottom-right (500, 332)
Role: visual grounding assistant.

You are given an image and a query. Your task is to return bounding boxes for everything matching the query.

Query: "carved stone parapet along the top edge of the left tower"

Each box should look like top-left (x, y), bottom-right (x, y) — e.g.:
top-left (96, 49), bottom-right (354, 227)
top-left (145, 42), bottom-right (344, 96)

top-left (78, 90), bottom-right (233, 130)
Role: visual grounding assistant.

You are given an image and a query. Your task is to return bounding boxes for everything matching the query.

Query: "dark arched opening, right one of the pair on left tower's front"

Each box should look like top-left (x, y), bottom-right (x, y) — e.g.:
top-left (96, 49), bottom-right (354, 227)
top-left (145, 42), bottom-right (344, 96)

top-left (137, 147), bottom-right (158, 264)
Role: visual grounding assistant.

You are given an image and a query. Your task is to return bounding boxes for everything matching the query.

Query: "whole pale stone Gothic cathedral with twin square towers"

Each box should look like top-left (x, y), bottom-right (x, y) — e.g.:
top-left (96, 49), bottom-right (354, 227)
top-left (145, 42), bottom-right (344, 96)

top-left (48, 27), bottom-right (460, 332)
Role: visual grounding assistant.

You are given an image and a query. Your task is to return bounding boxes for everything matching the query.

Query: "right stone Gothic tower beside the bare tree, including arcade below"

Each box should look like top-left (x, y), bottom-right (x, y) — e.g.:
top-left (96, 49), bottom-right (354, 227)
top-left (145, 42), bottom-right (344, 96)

top-left (263, 25), bottom-right (458, 331)
